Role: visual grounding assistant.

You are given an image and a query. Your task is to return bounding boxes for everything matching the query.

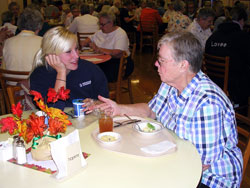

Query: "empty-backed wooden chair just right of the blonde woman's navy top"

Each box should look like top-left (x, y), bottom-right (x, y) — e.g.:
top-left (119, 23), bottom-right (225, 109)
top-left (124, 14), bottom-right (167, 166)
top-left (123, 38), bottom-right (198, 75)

top-left (108, 52), bottom-right (134, 103)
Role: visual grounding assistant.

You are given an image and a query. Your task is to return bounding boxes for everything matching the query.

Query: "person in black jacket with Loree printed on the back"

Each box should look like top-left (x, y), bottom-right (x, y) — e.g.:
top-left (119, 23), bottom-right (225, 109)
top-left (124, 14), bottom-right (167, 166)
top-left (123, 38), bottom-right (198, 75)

top-left (205, 7), bottom-right (250, 106)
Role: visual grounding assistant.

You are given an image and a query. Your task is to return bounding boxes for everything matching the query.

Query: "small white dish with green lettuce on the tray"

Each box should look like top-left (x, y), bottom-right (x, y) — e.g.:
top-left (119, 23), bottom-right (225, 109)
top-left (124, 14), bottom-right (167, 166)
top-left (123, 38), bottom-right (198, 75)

top-left (133, 121), bottom-right (163, 135)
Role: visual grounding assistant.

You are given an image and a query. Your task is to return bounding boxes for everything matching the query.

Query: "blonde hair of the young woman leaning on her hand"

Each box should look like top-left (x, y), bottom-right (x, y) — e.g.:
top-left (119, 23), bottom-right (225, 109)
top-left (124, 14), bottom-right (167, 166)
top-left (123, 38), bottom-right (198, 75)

top-left (33, 26), bottom-right (77, 70)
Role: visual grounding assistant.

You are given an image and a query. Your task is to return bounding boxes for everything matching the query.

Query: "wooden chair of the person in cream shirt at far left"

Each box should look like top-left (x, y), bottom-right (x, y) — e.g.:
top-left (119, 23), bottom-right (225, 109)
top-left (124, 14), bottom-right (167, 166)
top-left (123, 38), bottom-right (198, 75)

top-left (0, 69), bottom-right (29, 113)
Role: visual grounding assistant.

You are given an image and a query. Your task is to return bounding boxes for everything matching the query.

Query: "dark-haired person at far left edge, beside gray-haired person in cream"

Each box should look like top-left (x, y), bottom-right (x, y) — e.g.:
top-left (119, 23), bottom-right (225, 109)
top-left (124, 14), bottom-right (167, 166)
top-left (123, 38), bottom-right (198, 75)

top-left (1, 11), bottom-right (17, 36)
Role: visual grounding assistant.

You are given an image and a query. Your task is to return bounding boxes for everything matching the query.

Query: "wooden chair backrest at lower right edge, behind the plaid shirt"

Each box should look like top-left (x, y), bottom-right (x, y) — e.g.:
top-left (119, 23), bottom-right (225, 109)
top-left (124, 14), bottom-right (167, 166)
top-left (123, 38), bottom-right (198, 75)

top-left (235, 113), bottom-right (250, 179)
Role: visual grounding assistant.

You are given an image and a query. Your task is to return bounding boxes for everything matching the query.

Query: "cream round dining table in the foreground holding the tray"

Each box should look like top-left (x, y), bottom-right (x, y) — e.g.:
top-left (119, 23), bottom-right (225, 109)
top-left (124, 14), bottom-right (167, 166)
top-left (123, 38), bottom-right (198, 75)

top-left (0, 109), bottom-right (202, 188)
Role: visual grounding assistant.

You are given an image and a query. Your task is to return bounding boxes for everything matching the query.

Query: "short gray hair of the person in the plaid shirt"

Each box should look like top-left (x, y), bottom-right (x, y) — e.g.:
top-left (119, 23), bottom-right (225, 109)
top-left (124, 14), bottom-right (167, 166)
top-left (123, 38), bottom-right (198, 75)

top-left (157, 32), bottom-right (203, 73)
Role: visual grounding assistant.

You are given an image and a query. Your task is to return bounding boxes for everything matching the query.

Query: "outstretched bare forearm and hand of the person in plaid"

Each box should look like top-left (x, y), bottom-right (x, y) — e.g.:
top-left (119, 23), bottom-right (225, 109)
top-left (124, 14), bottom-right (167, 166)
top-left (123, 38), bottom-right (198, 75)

top-left (98, 96), bottom-right (156, 119)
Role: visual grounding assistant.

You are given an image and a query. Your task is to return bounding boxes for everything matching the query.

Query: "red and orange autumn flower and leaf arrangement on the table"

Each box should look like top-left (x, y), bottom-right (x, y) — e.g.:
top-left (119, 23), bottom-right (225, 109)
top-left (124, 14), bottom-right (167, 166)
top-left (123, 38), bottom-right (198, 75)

top-left (0, 87), bottom-right (71, 143)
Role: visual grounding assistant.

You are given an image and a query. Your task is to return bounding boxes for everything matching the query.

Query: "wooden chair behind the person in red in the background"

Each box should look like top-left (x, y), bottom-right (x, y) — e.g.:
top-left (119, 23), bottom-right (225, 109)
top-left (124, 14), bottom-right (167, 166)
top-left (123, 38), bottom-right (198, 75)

top-left (140, 21), bottom-right (159, 55)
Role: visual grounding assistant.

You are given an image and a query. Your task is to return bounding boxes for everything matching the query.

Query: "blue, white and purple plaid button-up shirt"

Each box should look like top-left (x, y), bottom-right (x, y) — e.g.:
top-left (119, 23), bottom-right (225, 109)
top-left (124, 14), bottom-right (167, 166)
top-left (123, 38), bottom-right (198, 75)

top-left (149, 71), bottom-right (243, 188)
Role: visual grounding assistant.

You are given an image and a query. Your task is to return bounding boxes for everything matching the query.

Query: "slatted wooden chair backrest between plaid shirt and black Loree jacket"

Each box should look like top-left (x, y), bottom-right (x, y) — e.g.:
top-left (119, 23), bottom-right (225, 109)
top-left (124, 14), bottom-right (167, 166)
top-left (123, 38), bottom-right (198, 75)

top-left (202, 53), bottom-right (229, 95)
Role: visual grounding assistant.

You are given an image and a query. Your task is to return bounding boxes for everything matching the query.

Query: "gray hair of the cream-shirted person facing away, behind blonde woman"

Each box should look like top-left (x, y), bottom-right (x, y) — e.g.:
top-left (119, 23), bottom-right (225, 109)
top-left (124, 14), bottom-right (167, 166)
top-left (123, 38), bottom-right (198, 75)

top-left (17, 8), bottom-right (43, 32)
